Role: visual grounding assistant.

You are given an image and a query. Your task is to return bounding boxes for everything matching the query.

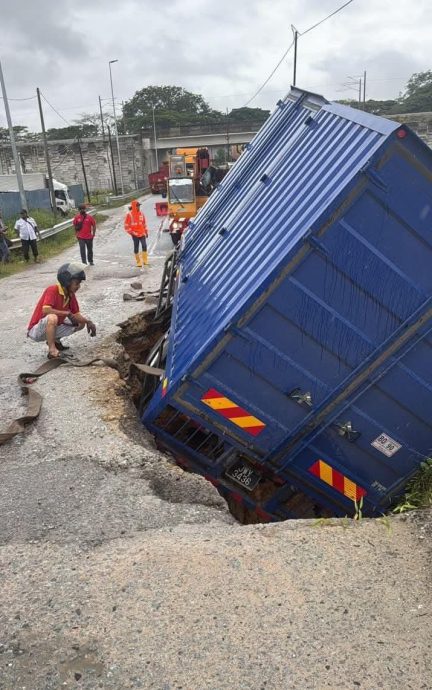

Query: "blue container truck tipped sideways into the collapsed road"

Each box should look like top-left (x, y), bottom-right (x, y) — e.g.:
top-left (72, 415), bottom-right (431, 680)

top-left (143, 84), bottom-right (432, 520)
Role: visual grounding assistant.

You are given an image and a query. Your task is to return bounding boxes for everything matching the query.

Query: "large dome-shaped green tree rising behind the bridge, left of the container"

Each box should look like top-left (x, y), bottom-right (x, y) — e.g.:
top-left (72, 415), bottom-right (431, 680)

top-left (123, 86), bottom-right (223, 132)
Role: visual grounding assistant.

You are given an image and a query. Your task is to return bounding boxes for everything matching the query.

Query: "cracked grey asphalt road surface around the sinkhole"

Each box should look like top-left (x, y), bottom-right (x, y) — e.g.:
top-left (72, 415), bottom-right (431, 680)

top-left (0, 198), bottom-right (432, 690)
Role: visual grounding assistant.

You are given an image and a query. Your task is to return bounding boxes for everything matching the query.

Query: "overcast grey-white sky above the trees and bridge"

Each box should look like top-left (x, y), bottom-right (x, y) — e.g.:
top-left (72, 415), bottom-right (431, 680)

top-left (0, 0), bottom-right (432, 131)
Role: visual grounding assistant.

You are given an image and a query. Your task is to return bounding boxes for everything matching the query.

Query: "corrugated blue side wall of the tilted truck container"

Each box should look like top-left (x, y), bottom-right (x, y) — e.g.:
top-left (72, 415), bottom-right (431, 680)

top-left (167, 90), bottom-right (398, 385)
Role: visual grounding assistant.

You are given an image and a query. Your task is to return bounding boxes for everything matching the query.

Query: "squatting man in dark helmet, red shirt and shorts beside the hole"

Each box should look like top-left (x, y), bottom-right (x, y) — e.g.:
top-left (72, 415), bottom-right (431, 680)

top-left (27, 263), bottom-right (96, 359)
